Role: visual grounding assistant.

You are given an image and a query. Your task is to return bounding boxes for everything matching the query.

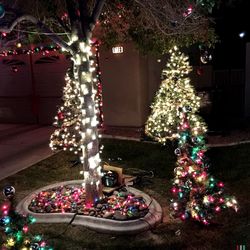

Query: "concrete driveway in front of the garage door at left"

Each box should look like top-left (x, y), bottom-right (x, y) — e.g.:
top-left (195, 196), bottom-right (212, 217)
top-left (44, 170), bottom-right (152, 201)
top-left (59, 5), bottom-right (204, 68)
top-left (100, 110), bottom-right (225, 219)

top-left (0, 124), bottom-right (54, 180)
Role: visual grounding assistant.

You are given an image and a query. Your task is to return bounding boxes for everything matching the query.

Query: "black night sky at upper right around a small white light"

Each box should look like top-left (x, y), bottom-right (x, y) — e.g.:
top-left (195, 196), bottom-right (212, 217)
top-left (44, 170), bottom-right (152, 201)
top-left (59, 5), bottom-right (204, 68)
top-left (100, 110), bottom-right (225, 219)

top-left (212, 0), bottom-right (250, 69)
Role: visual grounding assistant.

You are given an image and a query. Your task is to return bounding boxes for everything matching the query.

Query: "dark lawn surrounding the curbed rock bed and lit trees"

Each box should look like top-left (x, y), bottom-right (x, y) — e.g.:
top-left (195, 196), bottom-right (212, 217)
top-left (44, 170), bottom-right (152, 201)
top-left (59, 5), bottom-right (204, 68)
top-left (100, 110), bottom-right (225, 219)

top-left (0, 139), bottom-right (250, 250)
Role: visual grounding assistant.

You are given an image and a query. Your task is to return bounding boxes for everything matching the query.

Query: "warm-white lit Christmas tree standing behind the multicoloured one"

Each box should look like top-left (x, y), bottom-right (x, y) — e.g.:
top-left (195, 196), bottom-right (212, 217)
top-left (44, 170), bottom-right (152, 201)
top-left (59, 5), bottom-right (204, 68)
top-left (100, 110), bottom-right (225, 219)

top-left (145, 46), bottom-right (206, 144)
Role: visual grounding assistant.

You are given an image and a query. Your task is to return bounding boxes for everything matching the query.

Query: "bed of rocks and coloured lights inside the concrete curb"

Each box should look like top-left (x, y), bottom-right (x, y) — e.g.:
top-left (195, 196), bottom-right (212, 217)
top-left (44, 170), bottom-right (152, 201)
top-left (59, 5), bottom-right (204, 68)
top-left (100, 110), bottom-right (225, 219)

top-left (29, 186), bottom-right (148, 220)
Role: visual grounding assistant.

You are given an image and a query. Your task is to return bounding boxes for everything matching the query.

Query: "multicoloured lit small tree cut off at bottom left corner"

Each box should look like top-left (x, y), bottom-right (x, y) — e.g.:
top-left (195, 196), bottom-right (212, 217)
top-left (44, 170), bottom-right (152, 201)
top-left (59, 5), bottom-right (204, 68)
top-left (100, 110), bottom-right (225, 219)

top-left (0, 186), bottom-right (53, 250)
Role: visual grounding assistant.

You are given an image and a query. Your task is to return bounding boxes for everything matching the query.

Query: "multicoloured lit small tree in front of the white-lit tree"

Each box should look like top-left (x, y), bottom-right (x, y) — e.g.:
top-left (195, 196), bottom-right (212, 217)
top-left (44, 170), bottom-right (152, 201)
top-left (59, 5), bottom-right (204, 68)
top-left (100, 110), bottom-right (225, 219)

top-left (170, 106), bottom-right (238, 225)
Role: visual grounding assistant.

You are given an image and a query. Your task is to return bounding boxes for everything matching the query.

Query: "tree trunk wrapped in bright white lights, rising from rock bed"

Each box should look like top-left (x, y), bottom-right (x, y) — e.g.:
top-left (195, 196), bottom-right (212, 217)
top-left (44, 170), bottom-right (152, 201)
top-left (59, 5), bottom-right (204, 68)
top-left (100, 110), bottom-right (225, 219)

top-left (73, 42), bottom-right (102, 203)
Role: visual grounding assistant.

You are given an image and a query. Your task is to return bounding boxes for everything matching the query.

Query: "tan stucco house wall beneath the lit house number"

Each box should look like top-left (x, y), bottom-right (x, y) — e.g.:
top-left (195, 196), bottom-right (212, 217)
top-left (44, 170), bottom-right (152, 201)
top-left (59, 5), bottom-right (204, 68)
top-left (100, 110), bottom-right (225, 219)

top-left (100, 43), bottom-right (212, 127)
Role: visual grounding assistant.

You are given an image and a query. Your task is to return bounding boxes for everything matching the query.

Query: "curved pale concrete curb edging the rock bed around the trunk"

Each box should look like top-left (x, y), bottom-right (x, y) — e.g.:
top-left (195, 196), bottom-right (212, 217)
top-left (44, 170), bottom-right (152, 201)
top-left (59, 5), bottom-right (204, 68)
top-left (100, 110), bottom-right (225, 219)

top-left (16, 180), bottom-right (162, 234)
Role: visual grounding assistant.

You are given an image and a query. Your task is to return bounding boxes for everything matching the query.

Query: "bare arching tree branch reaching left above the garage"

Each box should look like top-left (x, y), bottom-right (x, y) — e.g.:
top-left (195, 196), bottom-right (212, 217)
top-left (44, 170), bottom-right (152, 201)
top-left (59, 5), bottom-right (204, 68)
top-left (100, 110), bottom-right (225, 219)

top-left (0, 15), bottom-right (73, 53)
